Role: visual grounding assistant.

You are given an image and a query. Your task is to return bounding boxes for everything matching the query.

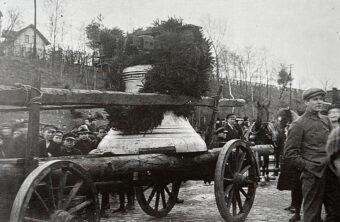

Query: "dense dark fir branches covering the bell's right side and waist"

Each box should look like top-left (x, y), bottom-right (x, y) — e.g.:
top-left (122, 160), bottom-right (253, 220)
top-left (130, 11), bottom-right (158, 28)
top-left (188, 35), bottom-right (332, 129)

top-left (106, 18), bottom-right (213, 134)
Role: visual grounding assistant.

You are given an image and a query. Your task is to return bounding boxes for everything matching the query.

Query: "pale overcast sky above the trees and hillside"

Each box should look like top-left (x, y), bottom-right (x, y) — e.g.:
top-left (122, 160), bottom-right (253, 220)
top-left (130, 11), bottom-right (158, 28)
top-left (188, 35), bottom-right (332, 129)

top-left (0, 0), bottom-right (340, 89)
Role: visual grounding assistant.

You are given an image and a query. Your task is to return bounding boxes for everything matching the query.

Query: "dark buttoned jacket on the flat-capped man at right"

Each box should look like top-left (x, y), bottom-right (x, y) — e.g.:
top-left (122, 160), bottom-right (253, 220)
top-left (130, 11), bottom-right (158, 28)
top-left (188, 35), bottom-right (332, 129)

top-left (284, 111), bottom-right (332, 178)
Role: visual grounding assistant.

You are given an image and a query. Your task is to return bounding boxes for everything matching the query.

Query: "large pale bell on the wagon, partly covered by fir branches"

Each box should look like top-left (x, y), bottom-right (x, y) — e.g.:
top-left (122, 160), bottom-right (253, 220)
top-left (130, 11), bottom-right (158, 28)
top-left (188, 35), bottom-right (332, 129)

top-left (91, 65), bottom-right (207, 154)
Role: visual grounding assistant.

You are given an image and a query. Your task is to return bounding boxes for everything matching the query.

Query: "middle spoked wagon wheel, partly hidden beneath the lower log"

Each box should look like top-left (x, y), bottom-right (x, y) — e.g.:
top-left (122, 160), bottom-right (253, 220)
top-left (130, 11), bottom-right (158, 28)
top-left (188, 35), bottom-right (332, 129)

top-left (135, 175), bottom-right (181, 217)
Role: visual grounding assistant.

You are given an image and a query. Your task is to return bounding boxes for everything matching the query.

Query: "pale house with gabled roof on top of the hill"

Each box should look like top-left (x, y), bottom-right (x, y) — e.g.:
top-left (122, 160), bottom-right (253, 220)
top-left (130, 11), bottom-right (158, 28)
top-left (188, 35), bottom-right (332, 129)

top-left (2, 24), bottom-right (50, 58)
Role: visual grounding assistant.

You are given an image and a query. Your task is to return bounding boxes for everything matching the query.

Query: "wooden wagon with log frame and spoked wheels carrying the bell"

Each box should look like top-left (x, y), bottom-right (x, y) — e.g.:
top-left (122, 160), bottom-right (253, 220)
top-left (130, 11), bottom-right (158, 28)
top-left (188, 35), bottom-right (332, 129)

top-left (0, 86), bottom-right (272, 221)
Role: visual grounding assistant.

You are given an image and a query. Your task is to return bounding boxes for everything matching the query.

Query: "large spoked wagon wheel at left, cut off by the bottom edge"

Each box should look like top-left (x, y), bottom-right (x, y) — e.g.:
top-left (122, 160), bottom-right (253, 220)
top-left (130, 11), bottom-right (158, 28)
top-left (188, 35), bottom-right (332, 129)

top-left (10, 160), bottom-right (100, 222)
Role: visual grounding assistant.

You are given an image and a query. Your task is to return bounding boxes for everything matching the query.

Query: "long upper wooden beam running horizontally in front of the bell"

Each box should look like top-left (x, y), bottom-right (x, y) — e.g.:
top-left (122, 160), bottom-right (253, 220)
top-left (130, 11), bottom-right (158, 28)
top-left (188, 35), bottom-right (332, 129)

top-left (0, 86), bottom-right (245, 107)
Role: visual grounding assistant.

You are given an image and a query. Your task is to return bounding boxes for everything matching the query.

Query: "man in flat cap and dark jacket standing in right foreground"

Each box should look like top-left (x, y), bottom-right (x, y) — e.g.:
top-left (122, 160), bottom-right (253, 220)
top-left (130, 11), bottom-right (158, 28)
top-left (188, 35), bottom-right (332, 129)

top-left (284, 88), bottom-right (340, 222)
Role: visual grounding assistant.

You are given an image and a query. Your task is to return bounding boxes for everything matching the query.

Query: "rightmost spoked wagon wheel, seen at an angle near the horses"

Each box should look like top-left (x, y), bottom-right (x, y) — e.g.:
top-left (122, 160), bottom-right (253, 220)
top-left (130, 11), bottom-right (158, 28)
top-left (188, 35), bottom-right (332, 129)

top-left (214, 140), bottom-right (258, 222)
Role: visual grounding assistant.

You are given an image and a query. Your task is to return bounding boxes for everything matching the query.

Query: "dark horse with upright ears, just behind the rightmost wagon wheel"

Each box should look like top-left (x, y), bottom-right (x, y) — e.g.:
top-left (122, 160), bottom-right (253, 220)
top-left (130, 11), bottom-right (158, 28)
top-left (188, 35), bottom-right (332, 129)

top-left (245, 102), bottom-right (278, 181)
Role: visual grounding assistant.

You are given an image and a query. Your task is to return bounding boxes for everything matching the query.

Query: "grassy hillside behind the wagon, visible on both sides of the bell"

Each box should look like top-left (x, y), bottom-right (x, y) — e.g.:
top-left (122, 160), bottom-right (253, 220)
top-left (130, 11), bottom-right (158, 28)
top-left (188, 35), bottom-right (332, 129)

top-left (0, 57), bottom-right (303, 132)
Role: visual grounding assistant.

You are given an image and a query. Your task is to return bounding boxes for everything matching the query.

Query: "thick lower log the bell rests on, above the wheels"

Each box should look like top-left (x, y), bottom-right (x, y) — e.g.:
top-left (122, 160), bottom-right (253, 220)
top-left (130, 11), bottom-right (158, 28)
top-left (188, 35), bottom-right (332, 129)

top-left (39, 148), bottom-right (221, 181)
